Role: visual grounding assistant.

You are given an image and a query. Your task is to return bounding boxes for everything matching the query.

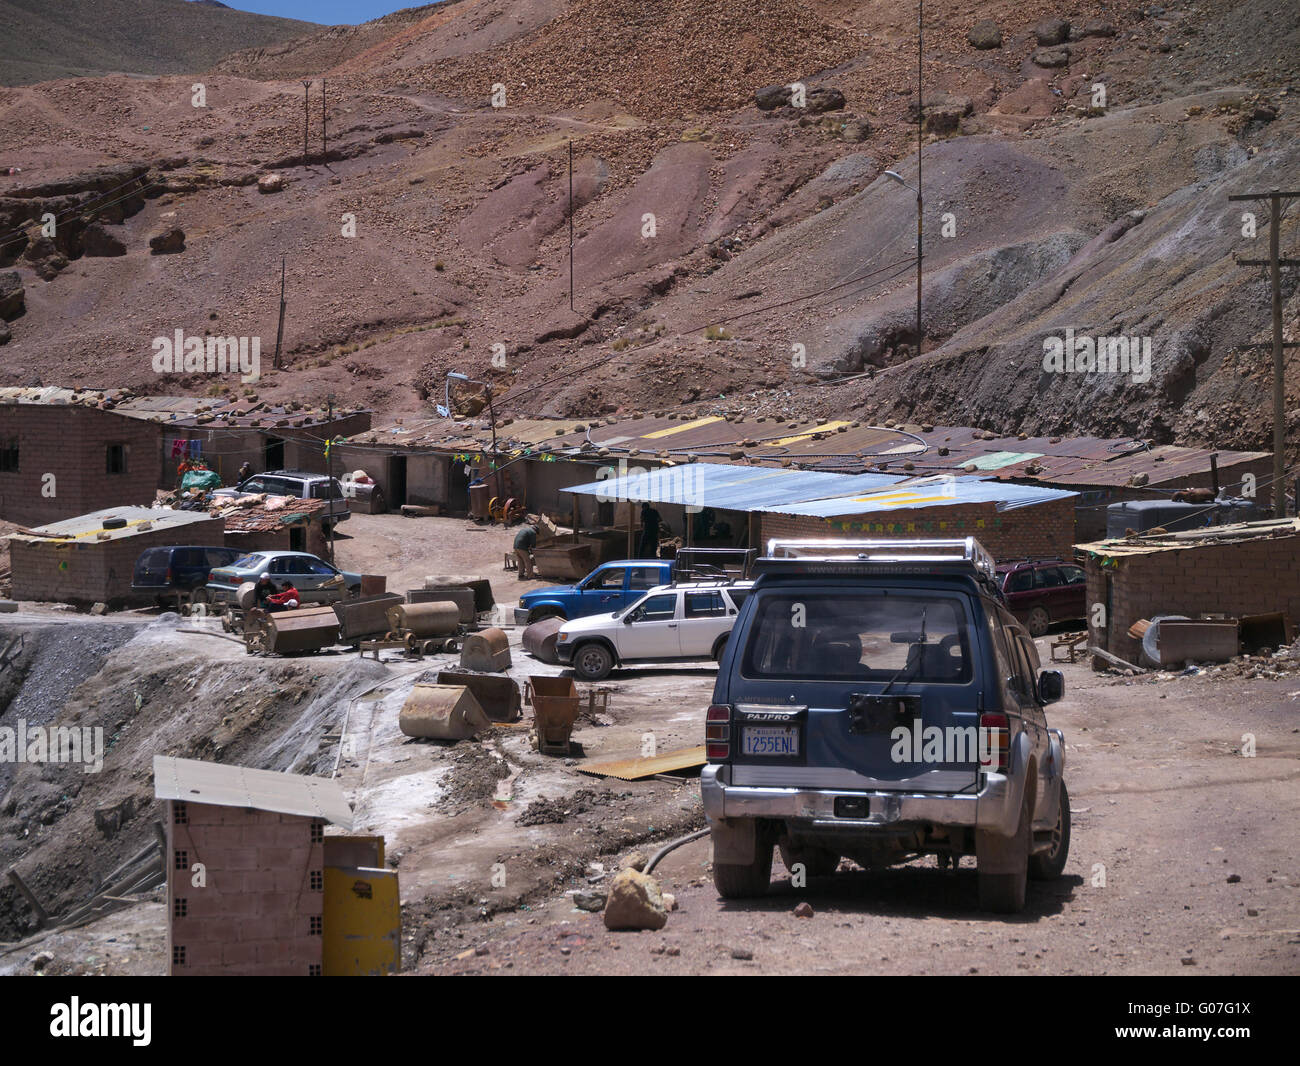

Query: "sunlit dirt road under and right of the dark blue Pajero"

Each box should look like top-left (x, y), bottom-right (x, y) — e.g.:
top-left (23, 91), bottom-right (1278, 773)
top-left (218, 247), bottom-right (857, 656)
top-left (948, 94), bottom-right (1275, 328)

top-left (431, 657), bottom-right (1300, 974)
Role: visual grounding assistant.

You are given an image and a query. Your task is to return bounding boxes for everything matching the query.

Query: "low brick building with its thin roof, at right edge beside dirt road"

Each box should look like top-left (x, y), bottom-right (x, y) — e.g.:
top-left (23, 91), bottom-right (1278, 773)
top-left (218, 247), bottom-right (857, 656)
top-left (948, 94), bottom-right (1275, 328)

top-left (1076, 519), bottom-right (1300, 663)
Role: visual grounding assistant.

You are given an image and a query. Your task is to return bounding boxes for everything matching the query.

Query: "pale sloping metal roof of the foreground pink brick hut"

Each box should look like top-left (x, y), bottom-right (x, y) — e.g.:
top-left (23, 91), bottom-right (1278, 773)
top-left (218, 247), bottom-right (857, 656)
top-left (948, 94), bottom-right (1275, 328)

top-left (153, 755), bottom-right (352, 831)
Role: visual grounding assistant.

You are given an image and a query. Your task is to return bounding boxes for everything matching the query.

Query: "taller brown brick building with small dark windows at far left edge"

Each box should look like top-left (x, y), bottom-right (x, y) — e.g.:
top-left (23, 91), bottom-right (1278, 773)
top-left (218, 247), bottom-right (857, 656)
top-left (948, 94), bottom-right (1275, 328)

top-left (0, 390), bottom-right (161, 525)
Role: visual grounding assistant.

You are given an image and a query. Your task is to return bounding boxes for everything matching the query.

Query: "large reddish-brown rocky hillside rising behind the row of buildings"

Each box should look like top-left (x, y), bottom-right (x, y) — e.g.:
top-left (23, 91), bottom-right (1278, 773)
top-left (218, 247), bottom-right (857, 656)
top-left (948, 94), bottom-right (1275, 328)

top-left (0, 0), bottom-right (1300, 462)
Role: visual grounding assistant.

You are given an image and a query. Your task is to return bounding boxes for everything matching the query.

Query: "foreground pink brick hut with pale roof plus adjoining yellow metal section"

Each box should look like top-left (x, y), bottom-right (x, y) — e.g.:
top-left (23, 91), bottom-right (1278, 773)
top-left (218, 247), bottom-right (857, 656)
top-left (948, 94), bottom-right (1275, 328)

top-left (153, 755), bottom-right (400, 976)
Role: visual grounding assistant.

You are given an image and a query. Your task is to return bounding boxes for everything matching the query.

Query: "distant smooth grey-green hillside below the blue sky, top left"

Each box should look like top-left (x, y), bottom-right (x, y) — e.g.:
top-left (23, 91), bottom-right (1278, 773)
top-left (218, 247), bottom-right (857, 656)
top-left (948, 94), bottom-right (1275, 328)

top-left (0, 0), bottom-right (316, 85)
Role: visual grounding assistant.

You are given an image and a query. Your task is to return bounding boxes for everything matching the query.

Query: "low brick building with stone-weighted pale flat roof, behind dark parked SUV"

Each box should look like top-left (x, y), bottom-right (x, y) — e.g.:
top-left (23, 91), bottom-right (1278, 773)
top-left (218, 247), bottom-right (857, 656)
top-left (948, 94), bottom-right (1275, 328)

top-left (9, 507), bottom-right (225, 607)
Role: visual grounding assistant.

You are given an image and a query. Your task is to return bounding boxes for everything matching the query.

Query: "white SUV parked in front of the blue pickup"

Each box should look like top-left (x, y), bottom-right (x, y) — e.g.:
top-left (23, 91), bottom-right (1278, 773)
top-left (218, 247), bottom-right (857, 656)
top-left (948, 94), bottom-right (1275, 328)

top-left (555, 581), bottom-right (754, 681)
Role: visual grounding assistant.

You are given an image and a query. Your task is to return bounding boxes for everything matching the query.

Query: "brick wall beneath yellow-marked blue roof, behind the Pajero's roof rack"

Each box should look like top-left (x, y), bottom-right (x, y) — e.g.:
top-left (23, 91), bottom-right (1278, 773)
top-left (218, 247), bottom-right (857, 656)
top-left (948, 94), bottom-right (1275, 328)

top-left (761, 497), bottom-right (1074, 562)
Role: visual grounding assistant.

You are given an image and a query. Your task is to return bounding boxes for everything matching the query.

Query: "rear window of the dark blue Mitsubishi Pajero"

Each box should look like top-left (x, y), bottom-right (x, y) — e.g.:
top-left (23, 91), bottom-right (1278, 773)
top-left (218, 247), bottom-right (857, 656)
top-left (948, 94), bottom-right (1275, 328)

top-left (741, 590), bottom-right (971, 684)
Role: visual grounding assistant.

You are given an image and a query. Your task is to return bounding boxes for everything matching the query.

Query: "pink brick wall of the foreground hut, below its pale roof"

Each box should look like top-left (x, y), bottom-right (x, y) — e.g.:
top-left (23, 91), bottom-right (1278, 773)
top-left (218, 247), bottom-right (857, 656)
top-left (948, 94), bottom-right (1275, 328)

top-left (166, 800), bottom-right (325, 978)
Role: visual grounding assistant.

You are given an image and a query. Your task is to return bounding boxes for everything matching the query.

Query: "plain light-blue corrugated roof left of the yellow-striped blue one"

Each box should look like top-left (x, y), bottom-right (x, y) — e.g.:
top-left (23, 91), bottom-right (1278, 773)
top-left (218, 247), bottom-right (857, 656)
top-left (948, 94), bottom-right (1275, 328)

top-left (562, 463), bottom-right (902, 511)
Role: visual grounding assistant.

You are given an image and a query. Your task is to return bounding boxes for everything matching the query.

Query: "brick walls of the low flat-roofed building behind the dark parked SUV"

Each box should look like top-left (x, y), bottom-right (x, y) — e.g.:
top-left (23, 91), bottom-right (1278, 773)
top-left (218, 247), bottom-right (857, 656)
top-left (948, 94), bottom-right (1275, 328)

top-left (9, 519), bottom-right (225, 607)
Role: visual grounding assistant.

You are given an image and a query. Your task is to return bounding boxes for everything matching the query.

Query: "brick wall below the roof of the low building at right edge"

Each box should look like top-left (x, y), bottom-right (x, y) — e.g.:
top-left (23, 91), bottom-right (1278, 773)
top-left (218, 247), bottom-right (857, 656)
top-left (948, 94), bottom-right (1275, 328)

top-left (1084, 536), bottom-right (1300, 666)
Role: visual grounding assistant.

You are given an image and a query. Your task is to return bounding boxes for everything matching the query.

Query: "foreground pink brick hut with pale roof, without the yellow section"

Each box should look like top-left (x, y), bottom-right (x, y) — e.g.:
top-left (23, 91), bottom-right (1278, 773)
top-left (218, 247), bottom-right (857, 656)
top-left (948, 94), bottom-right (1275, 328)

top-left (153, 755), bottom-right (352, 976)
